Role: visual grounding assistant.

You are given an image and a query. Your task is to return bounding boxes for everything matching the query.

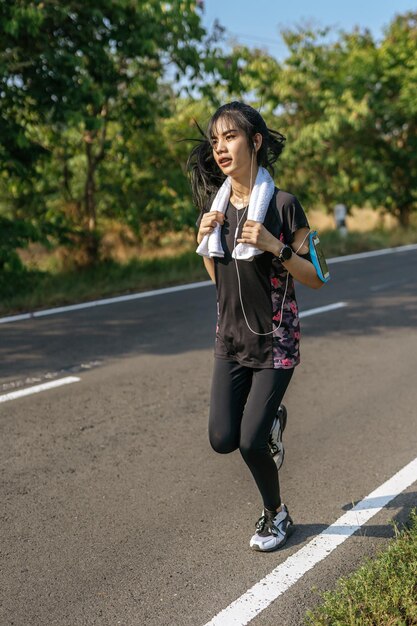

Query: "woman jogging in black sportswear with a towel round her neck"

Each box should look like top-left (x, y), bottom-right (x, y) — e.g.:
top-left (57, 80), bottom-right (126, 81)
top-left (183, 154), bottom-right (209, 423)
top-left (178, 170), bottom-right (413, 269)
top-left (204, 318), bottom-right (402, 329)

top-left (188, 102), bottom-right (323, 552)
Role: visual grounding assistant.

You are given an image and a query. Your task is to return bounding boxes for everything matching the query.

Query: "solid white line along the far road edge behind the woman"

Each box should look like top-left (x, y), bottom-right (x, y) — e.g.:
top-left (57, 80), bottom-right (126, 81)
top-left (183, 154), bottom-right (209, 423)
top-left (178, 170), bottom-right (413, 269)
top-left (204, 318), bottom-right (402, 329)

top-left (0, 244), bottom-right (417, 324)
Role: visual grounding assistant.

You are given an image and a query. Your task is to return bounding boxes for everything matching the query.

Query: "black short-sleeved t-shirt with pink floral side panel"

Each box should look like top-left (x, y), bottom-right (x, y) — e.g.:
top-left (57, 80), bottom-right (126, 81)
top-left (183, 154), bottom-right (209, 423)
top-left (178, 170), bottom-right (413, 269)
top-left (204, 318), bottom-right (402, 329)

top-left (198, 189), bottom-right (309, 369)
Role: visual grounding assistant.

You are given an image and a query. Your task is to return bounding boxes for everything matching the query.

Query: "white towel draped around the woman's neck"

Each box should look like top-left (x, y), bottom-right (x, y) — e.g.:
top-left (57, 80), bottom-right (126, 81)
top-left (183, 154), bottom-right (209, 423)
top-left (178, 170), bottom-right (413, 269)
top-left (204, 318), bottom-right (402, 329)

top-left (196, 167), bottom-right (275, 261)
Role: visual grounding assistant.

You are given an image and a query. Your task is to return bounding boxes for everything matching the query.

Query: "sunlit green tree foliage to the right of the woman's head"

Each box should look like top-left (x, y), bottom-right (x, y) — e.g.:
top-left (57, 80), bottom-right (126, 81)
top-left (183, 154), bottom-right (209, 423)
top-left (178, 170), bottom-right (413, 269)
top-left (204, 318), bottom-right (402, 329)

top-left (234, 13), bottom-right (417, 226)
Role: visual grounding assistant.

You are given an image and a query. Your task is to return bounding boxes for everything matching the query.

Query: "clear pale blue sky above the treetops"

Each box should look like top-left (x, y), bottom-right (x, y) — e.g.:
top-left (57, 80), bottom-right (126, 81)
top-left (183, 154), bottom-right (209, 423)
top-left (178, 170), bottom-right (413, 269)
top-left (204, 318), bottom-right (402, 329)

top-left (203, 0), bottom-right (417, 59)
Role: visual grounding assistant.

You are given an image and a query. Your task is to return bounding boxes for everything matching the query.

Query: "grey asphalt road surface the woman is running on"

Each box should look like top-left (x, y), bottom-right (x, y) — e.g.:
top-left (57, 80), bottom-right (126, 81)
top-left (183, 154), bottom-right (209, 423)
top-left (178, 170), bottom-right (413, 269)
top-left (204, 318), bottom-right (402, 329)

top-left (0, 251), bottom-right (417, 626)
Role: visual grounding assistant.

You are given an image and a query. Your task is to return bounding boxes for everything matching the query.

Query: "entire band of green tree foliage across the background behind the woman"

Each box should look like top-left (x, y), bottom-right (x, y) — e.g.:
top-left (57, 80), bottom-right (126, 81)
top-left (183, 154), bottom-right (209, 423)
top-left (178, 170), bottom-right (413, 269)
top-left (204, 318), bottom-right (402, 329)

top-left (0, 0), bottom-right (417, 278)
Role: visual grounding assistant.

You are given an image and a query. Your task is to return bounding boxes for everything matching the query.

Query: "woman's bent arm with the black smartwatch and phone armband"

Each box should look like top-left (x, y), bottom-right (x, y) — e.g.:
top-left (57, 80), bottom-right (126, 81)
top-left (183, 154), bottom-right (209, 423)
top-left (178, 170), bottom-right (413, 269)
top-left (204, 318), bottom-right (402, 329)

top-left (238, 220), bottom-right (324, 289)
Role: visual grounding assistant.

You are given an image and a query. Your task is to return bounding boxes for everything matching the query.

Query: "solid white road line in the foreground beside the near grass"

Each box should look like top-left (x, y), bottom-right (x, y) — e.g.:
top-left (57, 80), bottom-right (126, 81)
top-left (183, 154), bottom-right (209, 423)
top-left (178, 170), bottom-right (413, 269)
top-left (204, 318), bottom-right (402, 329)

top-left (205, 458), bottom-right (417, 626)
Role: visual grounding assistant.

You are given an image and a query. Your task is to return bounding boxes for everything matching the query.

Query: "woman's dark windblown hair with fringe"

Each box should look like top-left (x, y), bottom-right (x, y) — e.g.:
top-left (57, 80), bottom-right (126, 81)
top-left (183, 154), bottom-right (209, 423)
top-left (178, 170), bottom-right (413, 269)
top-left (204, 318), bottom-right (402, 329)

top-left (187, 101), bottom-right (285, 210)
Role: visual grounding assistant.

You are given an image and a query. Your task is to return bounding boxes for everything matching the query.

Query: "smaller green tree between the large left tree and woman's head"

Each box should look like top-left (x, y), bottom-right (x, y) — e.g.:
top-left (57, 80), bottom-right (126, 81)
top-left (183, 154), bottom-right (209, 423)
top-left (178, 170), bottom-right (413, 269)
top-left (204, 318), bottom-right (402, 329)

top-left (99, 95), bottom-right (210, 243)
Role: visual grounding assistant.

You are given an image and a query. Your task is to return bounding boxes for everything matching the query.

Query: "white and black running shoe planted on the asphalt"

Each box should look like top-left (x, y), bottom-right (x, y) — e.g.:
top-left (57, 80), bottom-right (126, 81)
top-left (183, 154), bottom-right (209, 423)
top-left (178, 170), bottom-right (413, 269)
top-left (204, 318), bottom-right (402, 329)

top-left (249, 504), bottom-right (293, 552)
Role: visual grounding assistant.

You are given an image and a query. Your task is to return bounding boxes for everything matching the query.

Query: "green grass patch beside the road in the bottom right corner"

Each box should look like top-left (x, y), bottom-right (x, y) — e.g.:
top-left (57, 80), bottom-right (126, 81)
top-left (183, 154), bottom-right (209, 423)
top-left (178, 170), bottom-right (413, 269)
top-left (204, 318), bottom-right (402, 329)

top-left (306, 509), bottom-right (417, 626)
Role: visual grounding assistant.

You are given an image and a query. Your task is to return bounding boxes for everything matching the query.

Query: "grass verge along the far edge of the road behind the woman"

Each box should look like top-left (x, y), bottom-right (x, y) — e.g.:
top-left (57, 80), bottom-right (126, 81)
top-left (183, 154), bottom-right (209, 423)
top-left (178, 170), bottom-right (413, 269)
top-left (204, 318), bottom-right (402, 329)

top-left (0, 227), bottom-right (417, 315)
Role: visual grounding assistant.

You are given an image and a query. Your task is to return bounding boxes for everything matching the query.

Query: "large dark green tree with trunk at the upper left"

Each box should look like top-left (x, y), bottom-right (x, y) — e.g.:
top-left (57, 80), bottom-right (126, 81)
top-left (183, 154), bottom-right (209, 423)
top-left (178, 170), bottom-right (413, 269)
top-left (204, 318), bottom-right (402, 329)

top-left (0, 0), bottom-right (240, 256)
